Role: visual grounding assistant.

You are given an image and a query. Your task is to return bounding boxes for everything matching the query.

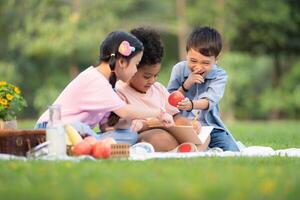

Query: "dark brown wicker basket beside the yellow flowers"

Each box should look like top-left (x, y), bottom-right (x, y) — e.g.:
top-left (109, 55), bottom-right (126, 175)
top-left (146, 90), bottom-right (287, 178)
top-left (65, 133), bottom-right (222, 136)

top-left (0, 129), bottom-right (46, 156)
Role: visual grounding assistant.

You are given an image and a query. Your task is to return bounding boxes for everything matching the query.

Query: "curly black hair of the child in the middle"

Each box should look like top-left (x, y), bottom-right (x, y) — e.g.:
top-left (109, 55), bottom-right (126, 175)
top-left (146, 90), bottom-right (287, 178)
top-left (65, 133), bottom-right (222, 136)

top-left (130, 27), bottom-right (164, 68)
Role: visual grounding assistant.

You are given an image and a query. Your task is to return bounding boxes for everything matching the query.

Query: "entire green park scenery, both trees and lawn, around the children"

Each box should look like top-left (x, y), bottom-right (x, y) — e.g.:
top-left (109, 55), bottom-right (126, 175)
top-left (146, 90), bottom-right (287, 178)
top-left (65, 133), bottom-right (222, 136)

top-left (0, 0), bottom-right (300, 200)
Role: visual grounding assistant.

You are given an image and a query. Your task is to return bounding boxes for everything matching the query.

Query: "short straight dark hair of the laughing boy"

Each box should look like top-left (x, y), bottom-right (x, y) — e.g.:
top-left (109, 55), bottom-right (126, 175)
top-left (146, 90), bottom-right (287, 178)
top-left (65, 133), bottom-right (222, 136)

top-left (186, 26), bottom-right (222, 57)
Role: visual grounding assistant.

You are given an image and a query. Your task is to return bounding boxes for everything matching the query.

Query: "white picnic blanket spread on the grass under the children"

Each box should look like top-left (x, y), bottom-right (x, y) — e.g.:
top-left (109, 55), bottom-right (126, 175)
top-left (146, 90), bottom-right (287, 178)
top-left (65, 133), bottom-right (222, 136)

top-left (0, 126), bottom-right (300, 162)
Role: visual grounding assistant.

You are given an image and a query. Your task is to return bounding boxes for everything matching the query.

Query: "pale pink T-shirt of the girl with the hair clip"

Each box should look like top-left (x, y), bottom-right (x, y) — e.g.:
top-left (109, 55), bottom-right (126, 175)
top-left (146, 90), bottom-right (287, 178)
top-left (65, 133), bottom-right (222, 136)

top-left (38, 67), bottom-right (126, 127)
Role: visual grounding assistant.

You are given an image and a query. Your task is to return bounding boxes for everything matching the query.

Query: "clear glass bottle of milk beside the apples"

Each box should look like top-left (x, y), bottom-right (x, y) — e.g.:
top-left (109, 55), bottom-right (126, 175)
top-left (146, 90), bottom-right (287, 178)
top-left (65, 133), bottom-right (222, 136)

top-left (46, 105), bottom-right (66, 156)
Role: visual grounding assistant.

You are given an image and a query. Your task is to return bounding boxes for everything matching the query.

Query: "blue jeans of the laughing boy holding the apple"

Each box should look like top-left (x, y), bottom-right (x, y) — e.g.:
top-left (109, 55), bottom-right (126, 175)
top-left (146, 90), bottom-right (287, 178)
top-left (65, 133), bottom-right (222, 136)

top-left (208, 129), bottom-right (240, 151)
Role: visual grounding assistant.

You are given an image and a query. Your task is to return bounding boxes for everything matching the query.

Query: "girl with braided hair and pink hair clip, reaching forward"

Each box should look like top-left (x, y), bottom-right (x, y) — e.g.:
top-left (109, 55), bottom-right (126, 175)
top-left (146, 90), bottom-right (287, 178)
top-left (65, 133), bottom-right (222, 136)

top-left (37, 31), bottom-right (174, 144)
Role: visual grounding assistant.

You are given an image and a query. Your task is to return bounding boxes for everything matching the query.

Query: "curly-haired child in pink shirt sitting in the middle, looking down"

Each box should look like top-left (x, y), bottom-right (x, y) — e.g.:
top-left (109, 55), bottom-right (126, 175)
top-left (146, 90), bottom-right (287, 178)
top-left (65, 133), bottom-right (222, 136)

top-left (106, 28), bottom-right (209, 151)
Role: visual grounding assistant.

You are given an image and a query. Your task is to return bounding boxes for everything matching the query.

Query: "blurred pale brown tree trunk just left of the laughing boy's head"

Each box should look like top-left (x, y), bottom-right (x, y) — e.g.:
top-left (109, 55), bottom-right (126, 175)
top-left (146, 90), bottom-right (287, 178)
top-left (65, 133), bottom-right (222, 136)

top-left (176, 0), bottom-right (187, 60)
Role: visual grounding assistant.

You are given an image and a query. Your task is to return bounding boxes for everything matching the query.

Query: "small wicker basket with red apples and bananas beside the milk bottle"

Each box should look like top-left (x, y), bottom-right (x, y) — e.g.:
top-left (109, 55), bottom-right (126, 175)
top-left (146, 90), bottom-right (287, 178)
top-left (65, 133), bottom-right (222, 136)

top-left (65, 126), bottom-right (129, 159)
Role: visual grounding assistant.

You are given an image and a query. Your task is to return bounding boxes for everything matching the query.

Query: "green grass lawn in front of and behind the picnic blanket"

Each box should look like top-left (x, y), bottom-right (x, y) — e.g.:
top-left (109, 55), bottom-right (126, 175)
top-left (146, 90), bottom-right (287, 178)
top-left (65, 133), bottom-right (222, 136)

top-left (0, 121), bottom-right (300, 200)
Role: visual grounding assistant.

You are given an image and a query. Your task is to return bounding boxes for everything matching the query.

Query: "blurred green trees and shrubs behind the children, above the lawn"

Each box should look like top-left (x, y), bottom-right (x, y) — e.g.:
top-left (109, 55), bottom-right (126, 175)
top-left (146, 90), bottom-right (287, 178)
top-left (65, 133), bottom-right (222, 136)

top-left (0, 0), bottom-right (300, 120)
